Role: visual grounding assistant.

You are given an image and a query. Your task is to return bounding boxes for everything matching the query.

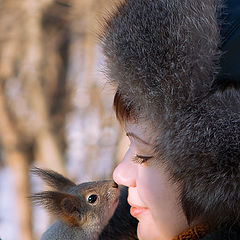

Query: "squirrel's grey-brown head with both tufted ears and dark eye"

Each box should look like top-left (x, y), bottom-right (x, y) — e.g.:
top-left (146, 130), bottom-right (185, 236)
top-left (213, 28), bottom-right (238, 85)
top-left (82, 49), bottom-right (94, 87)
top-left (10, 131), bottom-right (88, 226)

top-left (31, 168), bottom-right (119, 230)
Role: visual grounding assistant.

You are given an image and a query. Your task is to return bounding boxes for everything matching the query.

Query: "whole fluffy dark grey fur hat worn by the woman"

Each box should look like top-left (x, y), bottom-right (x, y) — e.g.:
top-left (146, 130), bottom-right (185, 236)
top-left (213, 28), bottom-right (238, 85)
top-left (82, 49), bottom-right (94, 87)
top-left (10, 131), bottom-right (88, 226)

top-left (102, 0), bottom-right (240, 226)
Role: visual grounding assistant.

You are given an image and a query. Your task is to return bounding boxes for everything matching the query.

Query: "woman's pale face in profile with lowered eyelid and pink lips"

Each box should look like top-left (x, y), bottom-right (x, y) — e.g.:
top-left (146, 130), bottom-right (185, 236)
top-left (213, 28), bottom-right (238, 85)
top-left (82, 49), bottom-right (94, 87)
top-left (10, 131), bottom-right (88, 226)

top-left (113, 123), bottom-right (189, 240)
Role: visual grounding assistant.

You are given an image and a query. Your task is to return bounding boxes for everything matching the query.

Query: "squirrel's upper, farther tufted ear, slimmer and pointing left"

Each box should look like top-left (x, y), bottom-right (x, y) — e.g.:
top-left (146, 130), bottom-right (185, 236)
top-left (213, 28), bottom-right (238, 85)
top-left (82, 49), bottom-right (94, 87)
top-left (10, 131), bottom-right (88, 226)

top-left (31, 167), bottom-right (76, 192)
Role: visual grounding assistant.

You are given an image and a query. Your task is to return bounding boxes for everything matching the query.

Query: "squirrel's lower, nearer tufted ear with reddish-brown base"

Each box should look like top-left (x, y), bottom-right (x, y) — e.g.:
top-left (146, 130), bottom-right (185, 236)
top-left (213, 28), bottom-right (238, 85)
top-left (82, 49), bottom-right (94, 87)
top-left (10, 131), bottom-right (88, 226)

top-left (30, 191), bottom-right (85, 226)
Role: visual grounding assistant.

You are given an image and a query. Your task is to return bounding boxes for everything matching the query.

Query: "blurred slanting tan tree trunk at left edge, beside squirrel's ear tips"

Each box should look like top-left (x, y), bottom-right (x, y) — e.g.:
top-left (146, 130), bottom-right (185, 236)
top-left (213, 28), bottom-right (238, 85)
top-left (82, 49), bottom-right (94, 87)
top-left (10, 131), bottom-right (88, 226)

top-left (0, 85), bottom-right (33, 240)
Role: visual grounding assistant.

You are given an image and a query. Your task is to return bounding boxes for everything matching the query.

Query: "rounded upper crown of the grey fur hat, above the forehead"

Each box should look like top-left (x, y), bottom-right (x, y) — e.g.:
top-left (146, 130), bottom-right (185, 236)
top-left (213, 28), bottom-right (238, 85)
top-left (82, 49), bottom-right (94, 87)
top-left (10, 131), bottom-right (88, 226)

top-left (102, 0), bottom-right (219, 116)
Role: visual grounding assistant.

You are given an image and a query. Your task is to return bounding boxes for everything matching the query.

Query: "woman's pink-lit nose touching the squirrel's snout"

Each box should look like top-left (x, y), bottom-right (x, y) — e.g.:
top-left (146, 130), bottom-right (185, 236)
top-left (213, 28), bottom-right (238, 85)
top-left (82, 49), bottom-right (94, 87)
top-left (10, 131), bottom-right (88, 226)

top-left (113, 150), bottom-right (136, 187)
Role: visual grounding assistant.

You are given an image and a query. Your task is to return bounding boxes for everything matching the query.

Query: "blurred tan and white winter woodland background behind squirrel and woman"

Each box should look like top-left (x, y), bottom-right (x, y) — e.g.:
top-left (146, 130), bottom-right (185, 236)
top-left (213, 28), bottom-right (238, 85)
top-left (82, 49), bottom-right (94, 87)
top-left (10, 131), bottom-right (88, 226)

top-left (0, 0), bottom-right (127, 240)
